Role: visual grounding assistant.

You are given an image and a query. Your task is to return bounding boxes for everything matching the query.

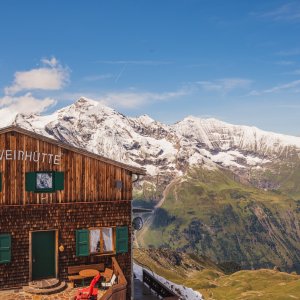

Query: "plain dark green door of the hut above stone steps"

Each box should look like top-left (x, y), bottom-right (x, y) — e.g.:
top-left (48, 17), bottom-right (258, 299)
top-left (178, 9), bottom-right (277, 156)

top-left (32, 231), bottom-right (55, 280)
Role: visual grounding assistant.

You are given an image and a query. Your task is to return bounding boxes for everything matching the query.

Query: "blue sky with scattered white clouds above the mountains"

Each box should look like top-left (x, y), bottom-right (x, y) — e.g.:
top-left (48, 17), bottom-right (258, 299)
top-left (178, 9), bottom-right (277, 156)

top-left (0, 0), bottom-right (300, 135)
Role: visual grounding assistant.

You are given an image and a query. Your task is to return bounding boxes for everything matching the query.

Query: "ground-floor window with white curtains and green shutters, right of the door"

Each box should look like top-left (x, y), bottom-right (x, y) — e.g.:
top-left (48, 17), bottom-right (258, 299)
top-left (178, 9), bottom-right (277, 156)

top-left (76, 227), bottom-right (128, 256)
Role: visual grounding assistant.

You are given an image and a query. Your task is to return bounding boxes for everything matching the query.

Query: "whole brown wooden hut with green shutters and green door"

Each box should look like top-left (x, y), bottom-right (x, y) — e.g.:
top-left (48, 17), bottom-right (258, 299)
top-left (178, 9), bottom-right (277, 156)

top-left (0, 126), bottom-right (144, 299)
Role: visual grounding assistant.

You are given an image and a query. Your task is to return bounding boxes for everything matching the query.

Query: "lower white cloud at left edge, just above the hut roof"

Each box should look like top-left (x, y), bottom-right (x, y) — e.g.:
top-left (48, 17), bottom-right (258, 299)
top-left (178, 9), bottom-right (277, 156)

top-left (0, 93), bottom-right (56, 127)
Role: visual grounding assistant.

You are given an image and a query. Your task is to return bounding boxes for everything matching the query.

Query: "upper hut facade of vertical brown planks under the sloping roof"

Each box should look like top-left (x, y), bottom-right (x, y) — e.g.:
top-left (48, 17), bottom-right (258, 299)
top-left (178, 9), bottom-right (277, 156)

top-left (0, 127), bottom-right (143, 205)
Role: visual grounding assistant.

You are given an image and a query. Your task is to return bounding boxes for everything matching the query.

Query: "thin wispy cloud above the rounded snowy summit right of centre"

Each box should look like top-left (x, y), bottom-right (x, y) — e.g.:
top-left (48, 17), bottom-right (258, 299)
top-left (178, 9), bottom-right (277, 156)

top-left (196, 78), bottom-right (252, 93)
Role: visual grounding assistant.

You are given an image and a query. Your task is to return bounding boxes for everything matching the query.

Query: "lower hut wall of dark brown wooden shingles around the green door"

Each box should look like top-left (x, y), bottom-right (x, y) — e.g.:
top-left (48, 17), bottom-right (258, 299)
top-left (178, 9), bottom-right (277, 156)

top-left (0, 201), bottom-right (131, 299)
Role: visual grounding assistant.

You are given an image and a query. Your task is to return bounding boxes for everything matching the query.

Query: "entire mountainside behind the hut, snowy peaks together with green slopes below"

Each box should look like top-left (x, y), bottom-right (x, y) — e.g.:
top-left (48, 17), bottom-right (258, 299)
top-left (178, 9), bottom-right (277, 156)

top-left (13, 97), bottom-right (300, 299)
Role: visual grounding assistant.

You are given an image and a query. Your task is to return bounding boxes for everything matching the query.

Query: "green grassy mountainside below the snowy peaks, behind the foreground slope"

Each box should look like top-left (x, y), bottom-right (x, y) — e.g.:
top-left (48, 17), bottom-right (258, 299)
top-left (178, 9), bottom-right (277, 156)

top-left (139, 169), bottom-right (300, 269)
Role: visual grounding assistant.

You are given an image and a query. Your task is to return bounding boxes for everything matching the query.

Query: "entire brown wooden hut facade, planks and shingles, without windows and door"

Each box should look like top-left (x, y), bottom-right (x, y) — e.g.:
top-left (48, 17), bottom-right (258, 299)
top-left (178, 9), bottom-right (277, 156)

top-left (0, 127), bottom-right (144, 299)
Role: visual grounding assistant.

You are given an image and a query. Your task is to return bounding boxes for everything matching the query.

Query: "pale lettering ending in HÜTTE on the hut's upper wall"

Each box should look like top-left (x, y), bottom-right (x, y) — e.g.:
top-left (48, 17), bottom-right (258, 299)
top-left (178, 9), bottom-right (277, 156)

top-left (0, 150), bottom-right (61, 165)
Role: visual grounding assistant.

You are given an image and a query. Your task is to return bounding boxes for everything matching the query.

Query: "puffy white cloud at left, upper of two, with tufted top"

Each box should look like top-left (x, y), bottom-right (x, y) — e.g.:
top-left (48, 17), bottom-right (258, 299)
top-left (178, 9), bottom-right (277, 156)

top-left (4, 57), bottom-right (69, 95)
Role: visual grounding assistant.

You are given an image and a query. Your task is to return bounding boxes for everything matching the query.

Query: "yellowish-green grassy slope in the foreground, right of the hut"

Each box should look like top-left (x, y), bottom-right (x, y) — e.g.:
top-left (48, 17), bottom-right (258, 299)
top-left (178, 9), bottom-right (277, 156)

top-left (134, 250), bottom-right (300, 300)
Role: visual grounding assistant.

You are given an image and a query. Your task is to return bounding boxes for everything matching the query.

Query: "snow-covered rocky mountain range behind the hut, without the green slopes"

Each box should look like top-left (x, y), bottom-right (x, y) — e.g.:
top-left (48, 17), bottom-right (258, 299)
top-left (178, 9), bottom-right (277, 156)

top-left (14, 97), bottom-right (300, 176)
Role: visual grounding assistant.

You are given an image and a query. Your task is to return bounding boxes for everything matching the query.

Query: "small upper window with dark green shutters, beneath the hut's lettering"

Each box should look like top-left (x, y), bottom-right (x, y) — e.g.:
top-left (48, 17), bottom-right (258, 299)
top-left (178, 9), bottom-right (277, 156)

top-left (26, 172), bottom-right (64, 193)
